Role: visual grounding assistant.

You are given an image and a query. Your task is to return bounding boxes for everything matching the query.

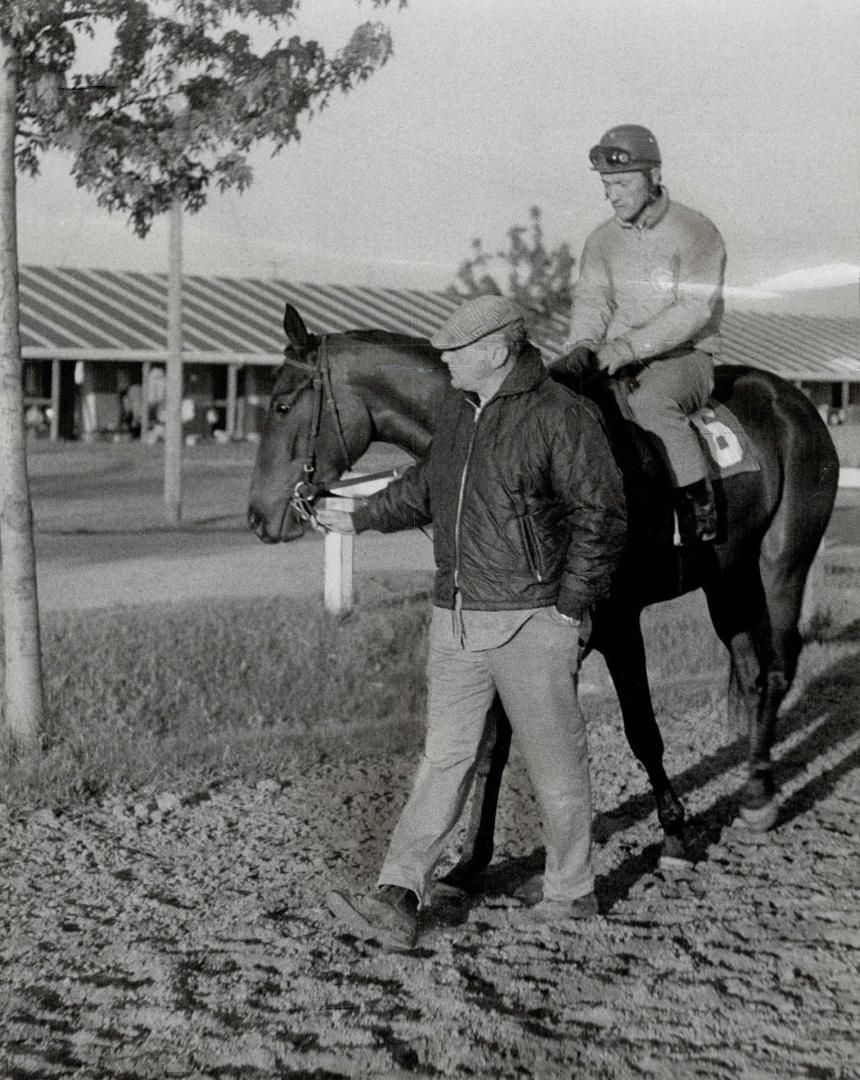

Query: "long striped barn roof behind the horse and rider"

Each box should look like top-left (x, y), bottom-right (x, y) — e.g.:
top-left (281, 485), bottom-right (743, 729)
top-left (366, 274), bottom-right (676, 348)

top-left (21, 267), bottom-right (860, 381)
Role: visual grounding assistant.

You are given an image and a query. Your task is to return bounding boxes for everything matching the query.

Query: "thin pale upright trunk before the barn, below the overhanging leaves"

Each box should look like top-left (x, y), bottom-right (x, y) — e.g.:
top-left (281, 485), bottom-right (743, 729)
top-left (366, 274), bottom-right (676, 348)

top-left (164, 197), bottom-right (183, 525)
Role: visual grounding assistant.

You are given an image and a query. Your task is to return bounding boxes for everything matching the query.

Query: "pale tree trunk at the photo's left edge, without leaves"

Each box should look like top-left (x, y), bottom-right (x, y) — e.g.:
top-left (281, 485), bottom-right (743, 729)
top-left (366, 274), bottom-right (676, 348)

top-left (0, 33), bottom-right (44, 746)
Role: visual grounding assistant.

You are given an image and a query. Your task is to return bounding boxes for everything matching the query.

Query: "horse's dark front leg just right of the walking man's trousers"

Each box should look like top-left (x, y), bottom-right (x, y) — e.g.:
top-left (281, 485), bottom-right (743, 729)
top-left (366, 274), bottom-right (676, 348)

top-left (591, 608), bottom-right (691, 869)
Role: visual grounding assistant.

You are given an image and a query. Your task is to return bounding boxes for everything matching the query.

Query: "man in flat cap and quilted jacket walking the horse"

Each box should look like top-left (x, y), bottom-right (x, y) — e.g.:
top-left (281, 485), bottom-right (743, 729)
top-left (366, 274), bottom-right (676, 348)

top-left (317, 296), bottom-right (626, 947)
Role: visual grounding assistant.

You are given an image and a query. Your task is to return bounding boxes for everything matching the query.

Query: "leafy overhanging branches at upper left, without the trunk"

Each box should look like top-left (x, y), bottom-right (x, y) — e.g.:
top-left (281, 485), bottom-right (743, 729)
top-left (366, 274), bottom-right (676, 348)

top-left (10, 0), bottom-right (404, 235)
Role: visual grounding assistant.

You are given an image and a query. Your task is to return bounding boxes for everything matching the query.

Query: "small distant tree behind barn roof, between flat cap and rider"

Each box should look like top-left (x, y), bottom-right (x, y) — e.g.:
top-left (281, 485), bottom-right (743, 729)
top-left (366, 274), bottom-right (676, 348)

top-left (448, 206), bottom-right (575, 326)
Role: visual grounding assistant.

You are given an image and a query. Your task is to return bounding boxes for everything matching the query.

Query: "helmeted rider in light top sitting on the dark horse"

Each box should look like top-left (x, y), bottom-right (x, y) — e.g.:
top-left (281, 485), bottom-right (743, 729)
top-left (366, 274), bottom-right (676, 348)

top-left (553, 124), bottom-right (726, 544)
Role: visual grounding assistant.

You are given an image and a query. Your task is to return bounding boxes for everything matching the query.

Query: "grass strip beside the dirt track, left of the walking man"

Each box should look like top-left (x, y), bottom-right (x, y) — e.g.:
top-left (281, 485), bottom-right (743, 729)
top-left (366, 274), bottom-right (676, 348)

top-left (0, 576), bottom-right (430, 809)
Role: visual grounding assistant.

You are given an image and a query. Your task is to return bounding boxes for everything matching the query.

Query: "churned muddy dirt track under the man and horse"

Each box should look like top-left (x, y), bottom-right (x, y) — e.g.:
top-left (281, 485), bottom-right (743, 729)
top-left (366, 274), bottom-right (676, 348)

top-left (0, 639), bottom-right (860, 1080)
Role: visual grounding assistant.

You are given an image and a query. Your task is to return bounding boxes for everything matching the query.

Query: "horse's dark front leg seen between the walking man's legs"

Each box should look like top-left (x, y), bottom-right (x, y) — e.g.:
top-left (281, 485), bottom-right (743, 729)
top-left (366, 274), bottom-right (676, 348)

top-left (441, 694), bottom-right (511, 893)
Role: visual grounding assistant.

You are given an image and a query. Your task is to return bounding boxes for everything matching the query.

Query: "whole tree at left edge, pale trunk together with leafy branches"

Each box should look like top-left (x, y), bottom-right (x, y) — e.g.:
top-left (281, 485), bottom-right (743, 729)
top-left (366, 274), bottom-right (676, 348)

top-left (0, 0), bottom-right (405, 742)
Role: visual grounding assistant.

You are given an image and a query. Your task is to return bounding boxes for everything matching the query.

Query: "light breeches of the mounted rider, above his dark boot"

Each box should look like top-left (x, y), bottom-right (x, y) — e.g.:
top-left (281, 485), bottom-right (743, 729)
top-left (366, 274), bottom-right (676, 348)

top-left (628, 351), bottom-right (714, 487)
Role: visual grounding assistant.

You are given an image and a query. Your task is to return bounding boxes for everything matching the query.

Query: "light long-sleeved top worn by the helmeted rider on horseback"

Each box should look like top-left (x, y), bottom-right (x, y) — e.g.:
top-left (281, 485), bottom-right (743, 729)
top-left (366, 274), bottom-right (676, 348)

top-left (566, 190), bottom-right (726, 361)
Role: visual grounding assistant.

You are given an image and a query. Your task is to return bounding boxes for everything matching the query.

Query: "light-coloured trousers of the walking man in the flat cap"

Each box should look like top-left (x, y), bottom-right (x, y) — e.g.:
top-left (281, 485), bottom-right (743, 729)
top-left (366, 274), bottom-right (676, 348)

top-left (379, 608), bottom-right (594, 900)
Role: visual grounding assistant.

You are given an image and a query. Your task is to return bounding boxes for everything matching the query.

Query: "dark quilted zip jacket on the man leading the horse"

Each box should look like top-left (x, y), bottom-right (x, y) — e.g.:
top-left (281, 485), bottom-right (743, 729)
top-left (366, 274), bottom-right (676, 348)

top-left (353, 346), bottom-right (626, 618)
